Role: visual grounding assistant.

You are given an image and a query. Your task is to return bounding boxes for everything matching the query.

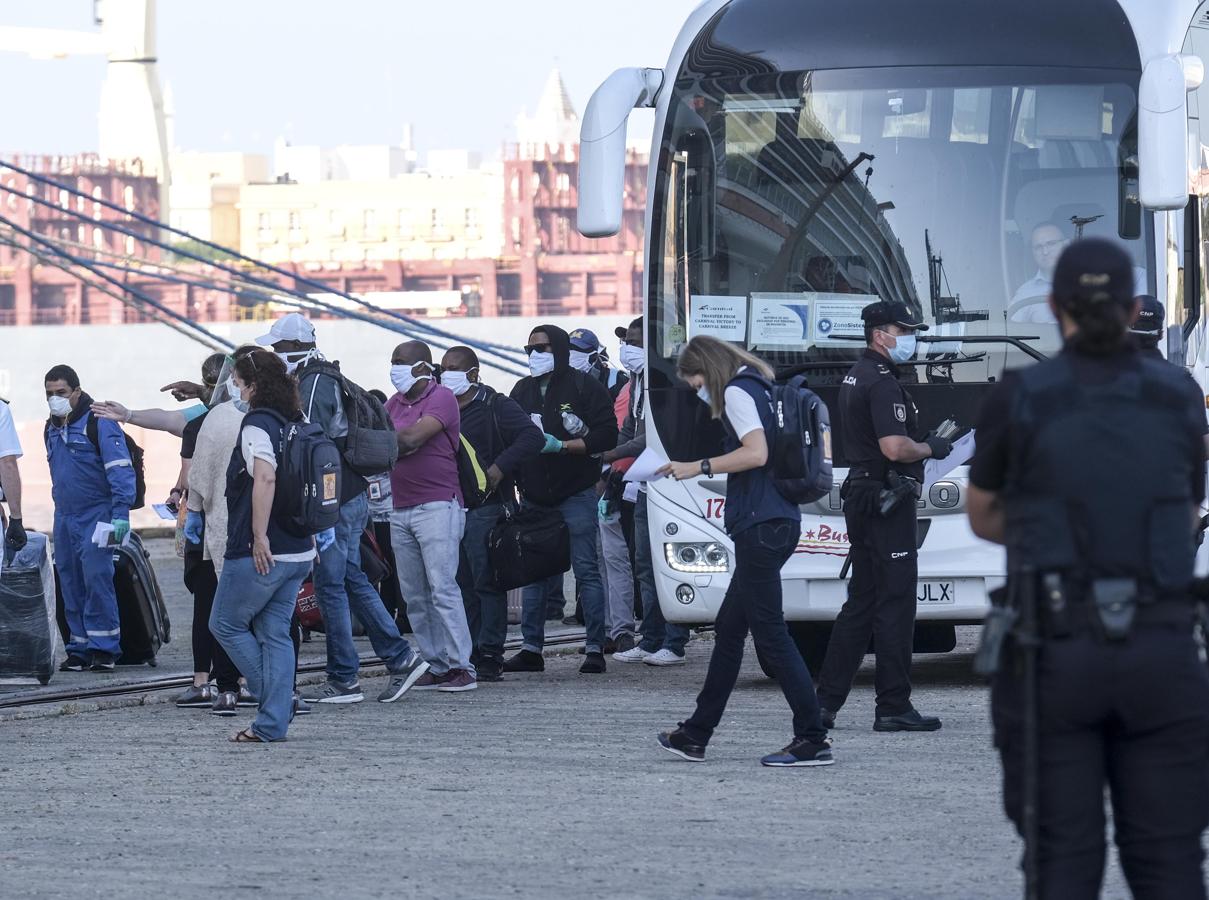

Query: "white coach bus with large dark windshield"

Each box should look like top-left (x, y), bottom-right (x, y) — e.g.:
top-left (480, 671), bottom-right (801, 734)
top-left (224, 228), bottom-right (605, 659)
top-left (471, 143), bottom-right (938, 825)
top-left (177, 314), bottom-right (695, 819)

top-left (579, 0), bottom-right (1209, 668)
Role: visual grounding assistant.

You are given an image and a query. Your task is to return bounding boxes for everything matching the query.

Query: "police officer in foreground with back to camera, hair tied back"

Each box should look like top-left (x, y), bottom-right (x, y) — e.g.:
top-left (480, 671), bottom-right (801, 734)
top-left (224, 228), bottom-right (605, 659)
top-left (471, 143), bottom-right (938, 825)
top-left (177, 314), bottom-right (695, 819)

top-left (967, 238), bottom-right (1209, 900)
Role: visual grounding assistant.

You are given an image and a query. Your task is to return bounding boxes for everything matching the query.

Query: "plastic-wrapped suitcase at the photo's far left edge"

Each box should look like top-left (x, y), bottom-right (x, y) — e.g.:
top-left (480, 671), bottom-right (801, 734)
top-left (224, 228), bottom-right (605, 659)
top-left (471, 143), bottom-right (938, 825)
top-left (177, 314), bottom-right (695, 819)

top-left (0, 531), bottom-right (63, 685)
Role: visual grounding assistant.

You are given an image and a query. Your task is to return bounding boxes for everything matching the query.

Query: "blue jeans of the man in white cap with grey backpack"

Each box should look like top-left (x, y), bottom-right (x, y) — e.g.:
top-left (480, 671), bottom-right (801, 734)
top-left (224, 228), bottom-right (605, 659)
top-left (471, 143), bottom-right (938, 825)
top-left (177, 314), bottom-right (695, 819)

top-left (314, 494), bottom-right (411, 685)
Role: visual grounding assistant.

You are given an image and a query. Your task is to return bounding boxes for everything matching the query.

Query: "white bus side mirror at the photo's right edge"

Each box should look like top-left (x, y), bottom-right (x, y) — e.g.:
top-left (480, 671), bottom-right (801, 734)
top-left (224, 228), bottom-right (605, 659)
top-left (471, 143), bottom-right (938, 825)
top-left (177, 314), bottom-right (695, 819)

top-left (1138, 53), bottom-right (1204, 209)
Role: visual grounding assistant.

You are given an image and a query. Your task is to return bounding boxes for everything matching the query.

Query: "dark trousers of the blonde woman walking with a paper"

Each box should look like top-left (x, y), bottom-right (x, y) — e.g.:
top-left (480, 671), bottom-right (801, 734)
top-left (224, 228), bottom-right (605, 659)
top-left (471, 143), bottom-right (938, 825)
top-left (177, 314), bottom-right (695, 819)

top-left (682, 519), bottom-right (827, 744)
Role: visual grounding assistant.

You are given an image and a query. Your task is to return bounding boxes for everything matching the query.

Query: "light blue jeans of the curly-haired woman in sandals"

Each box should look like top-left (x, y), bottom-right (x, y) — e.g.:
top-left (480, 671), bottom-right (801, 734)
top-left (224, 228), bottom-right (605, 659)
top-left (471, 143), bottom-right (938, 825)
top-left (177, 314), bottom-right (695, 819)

top-left (210, 556), bottom-right (311, 740)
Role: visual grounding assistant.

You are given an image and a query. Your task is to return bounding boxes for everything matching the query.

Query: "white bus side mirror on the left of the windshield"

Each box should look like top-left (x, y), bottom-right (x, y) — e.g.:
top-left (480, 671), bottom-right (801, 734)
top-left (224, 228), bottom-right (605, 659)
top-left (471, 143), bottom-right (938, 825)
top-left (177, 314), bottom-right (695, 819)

top-left (578, 69), bottom-right (664, 237)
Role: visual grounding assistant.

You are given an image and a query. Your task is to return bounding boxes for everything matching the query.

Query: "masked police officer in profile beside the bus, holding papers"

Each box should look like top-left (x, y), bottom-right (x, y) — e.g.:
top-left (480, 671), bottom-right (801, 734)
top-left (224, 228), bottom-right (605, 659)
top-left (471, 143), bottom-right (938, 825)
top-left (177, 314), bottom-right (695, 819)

top-left (817, 301), bottom-right (953, 732)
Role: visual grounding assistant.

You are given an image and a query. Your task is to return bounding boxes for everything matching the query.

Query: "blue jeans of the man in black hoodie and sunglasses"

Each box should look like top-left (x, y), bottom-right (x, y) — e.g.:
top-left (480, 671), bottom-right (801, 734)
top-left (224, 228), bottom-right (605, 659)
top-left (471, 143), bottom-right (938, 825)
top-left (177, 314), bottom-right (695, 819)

top-left (521, 488), bottom-right (605, 653)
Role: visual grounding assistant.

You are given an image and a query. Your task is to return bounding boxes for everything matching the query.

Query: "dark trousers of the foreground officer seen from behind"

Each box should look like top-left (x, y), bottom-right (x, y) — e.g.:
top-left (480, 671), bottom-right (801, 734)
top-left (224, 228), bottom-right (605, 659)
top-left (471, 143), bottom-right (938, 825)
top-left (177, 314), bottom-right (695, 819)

top-left (991, 625), bottom-right (1209, 900)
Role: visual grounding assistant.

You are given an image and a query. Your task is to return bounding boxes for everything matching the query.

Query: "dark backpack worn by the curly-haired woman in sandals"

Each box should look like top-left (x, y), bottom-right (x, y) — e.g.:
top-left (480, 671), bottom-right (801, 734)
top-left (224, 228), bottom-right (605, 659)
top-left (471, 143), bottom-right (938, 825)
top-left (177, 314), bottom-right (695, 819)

top-left (256, 409), bottom-right (341, 537)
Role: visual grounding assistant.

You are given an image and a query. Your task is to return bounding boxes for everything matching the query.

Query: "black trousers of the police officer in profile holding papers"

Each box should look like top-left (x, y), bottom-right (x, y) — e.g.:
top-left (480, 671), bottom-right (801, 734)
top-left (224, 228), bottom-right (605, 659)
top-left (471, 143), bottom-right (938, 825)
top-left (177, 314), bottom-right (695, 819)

top-left (818, 502), bottom-right (918, 716)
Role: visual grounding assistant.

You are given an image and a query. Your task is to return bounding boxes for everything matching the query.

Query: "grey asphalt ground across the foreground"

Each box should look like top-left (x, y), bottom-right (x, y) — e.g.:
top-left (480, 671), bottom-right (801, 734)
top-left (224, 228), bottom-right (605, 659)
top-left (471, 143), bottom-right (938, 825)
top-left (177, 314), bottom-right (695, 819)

top-left (0, 549), bottom-right (1141, 900)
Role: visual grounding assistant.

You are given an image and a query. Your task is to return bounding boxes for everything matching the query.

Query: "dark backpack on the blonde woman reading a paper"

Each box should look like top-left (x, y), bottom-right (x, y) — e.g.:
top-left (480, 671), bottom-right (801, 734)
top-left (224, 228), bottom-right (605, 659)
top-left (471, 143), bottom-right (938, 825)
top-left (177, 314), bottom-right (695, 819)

top-left (737, 373), bottom-right (832, 503)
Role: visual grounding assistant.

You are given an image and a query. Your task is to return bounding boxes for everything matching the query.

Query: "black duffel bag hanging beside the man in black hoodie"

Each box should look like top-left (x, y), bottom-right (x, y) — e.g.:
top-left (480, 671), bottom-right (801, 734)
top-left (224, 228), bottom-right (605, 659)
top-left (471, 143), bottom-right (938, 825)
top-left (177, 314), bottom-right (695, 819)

top-left (487, 506), bottom-right (571, 590)
